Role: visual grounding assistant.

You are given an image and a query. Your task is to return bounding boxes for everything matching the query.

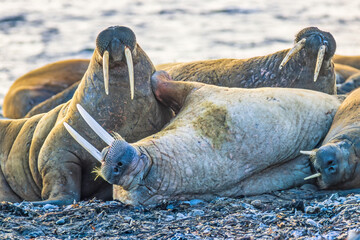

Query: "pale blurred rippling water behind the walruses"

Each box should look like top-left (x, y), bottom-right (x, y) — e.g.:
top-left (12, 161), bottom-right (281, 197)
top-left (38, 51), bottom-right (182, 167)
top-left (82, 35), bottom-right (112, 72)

top-left (0, 0), bottom-right (360, 105)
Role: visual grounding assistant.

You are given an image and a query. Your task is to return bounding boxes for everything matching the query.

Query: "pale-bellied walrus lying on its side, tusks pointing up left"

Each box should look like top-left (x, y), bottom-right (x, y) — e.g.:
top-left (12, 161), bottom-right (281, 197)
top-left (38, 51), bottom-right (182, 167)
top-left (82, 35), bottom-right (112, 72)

top-left (64, 72), bottom-right (340, 205)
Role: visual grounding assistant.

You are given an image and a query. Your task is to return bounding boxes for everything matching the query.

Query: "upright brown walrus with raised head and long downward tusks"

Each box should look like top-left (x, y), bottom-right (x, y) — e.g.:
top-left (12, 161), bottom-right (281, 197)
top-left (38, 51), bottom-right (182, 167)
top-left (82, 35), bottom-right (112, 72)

top-left (0, 26), bottom-right (173, 205)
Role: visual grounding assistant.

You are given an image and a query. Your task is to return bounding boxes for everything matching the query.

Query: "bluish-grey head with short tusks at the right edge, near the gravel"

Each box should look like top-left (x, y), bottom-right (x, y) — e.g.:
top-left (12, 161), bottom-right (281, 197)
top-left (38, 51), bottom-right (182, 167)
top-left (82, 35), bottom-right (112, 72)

top-left (301, 139), bottom-right (360, 189)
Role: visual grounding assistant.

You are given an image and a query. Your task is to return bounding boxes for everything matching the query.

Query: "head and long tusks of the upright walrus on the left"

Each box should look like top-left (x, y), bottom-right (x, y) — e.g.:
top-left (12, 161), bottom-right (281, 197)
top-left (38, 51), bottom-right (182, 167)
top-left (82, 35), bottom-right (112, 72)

top-left (95, 26), bottom-right (136, 99)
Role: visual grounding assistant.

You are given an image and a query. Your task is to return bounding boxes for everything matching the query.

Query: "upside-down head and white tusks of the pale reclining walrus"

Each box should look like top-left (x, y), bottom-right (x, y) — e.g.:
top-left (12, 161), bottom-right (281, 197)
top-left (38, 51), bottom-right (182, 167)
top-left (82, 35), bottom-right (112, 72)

top-left (64, 104), bottom-right (151, 190)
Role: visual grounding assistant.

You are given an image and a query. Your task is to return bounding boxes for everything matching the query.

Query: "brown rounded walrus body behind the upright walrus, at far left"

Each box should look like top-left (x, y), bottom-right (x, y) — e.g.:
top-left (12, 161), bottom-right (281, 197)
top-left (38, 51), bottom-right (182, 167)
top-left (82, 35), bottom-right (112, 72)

top-left (3, 59), bottom-right (89, 118)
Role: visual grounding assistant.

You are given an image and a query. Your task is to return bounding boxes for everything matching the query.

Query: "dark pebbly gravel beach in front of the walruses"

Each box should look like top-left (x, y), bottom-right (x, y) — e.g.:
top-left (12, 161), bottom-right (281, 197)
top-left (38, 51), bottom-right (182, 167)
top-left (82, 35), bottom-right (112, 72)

top-left (0, 185), bottom-right (360, 239)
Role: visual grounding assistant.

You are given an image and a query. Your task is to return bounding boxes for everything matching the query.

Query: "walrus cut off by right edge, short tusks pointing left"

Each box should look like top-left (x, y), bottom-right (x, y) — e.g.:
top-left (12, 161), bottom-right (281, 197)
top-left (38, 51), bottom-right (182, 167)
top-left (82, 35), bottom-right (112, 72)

top-left (302, 89), bottom-right (360, 189)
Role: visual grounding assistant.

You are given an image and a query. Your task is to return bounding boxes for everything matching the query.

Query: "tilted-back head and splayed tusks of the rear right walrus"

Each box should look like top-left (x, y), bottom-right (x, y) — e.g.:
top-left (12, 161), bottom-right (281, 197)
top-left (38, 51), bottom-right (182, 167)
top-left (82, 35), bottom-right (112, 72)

top-left (279, 27), bottom-right (336, 82)
